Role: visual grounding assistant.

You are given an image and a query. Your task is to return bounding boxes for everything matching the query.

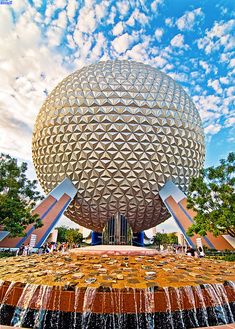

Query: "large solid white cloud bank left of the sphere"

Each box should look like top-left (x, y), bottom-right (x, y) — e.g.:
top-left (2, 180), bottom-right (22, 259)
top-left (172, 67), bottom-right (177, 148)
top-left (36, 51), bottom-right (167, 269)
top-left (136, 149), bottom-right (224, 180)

top-left (0, 4), bottom-right (71, 160)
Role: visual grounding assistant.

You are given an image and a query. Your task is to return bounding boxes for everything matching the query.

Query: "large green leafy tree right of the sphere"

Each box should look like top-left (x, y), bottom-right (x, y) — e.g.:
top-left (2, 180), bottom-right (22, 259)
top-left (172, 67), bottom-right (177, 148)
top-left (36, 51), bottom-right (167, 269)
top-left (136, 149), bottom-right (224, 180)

top-left (187, 153), bottom-right (235, 237)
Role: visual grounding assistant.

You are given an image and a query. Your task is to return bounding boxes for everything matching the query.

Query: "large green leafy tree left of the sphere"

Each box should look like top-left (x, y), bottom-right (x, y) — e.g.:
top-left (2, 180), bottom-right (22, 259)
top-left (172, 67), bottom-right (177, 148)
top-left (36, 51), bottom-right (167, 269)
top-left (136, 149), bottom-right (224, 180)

top-left (0, 154), bottom-right (42, 237)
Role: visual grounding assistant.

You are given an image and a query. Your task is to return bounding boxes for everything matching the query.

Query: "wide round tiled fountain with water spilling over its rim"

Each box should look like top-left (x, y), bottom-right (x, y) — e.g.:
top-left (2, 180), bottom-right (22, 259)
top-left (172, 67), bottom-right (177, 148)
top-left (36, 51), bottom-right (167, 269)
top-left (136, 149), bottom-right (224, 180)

top-left (0, 252), bottom-right (235, 329)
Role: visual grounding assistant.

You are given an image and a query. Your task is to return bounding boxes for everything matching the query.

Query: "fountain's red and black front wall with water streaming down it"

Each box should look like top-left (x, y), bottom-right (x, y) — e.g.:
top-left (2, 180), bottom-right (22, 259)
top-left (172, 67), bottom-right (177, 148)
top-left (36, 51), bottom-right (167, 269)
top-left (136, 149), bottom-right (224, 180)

top-left (0, 282), bottom-right (235, 329)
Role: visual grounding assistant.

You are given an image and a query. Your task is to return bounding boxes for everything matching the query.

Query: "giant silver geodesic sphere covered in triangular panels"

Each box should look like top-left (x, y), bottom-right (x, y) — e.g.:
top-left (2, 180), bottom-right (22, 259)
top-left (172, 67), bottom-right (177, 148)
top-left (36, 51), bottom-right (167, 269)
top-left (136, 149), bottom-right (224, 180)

top-left (33, 60), bottom-right (204, 232)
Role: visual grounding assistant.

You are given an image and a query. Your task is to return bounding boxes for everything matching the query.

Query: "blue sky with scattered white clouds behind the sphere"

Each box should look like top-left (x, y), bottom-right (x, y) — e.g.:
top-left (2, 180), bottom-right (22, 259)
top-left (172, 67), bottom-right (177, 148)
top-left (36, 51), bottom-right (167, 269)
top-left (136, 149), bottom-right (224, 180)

top-left (0, 0), bottom-right (235, 231)
